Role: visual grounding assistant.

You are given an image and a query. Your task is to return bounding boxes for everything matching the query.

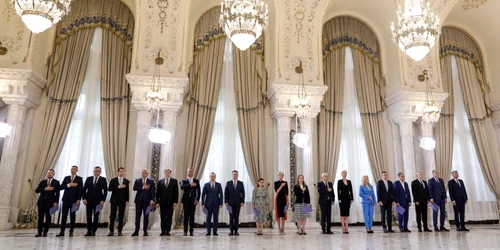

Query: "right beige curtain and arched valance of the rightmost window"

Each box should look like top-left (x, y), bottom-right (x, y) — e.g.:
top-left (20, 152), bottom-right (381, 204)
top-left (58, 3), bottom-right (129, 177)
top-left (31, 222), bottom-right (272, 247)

top-left (436, 27), bottom-right (500, 200)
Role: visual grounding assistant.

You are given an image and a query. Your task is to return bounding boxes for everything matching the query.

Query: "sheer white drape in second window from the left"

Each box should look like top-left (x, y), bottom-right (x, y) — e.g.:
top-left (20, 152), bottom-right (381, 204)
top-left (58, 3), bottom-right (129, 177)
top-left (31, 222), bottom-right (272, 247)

top-left (196, 39), bottom-right (254, 224)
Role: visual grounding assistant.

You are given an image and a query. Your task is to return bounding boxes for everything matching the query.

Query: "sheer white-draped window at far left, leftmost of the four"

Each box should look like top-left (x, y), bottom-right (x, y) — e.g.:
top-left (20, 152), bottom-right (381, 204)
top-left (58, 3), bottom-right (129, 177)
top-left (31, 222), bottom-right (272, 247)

top-left (54, 28), bottom-right (106, 222)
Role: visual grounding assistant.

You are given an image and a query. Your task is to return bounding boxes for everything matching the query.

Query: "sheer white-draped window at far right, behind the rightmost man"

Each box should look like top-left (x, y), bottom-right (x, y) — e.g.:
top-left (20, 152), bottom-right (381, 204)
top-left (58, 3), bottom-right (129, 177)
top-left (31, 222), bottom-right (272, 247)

top-left (452, 56), bottom-right (498, 220)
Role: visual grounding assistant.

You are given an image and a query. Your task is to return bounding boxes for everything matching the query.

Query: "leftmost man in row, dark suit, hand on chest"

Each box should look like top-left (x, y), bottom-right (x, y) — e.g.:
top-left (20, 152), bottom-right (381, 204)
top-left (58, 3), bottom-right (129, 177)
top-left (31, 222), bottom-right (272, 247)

top-left (35, 169), bottom-right (60, 237)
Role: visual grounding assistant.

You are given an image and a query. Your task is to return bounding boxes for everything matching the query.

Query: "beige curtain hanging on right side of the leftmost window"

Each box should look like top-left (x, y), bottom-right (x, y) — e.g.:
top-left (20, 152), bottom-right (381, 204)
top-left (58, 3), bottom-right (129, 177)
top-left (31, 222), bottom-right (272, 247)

top-left (101, 3), bottom-right (134, 179)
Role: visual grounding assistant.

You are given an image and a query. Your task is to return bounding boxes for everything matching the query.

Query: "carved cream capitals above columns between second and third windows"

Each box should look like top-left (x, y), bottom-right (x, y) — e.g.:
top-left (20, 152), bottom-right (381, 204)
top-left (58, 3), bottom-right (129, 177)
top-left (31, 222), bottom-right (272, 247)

top-left (267, 83), bottom-right (328, 118)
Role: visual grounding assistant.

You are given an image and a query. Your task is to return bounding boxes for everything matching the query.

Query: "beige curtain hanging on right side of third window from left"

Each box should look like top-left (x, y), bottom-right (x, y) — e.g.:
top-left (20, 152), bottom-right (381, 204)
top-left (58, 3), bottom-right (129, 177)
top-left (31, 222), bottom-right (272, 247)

top-left (352, 49), bottom-right (387, 179)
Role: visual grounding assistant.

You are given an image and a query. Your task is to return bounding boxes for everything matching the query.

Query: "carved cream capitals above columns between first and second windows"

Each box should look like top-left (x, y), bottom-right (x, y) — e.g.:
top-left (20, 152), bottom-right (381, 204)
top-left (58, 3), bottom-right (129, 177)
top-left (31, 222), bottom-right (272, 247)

top-left (126, 74), bottom-right (189, 112)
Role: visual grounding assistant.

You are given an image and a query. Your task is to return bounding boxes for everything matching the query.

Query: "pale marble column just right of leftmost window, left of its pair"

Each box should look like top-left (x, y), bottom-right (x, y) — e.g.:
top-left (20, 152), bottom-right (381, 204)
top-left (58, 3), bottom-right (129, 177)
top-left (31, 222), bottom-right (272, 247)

top-left (124, 110), bottom-right (152, 230)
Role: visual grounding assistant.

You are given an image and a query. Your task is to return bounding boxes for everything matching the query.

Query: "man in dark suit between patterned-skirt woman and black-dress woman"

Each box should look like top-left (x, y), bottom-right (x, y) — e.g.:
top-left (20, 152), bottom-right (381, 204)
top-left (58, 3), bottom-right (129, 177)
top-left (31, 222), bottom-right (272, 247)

top-left (318, 173), bottom-right (335, 234)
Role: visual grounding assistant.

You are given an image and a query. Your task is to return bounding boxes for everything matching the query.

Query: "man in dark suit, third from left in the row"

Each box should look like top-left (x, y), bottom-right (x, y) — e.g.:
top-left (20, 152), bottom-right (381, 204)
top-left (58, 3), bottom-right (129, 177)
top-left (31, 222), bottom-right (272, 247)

top-left (83, 166), bottom-right (108, 236)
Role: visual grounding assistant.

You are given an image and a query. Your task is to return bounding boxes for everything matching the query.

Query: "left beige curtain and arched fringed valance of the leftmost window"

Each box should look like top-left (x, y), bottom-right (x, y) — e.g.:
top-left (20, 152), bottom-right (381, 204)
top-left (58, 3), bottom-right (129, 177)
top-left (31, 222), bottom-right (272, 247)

top-left (33, 0), bottom-right (134, 183)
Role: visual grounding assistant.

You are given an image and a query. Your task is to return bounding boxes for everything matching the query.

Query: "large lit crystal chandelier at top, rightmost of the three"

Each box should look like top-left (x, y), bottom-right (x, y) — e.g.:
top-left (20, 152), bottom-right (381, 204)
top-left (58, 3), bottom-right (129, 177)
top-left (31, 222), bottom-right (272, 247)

top-left (391, 0), bottom-right (441, 61)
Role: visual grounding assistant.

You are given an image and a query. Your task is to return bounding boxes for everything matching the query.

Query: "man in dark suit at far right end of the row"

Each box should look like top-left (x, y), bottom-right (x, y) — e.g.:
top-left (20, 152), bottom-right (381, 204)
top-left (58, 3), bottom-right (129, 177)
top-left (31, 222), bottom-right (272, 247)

top-left (448, 170), bottom-right (469, 231)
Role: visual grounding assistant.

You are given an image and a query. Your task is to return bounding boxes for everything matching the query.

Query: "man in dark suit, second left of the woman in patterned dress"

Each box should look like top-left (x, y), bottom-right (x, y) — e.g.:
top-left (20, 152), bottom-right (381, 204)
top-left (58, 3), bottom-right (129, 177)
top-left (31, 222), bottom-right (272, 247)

top-left (201, 172), bottom-right (224, 236)
